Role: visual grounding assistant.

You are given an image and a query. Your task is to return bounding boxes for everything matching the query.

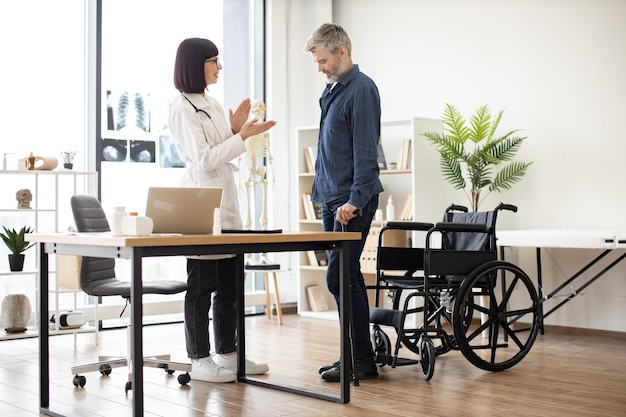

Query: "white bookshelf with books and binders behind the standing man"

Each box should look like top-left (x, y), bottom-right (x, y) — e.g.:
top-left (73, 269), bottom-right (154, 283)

top-left (296, 117), bottom-right (443, 320)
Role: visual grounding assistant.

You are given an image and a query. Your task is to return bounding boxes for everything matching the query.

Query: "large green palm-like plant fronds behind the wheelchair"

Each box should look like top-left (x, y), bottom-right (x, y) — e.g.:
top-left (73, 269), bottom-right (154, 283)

top-left (422, 104), bottom-right (532, 211)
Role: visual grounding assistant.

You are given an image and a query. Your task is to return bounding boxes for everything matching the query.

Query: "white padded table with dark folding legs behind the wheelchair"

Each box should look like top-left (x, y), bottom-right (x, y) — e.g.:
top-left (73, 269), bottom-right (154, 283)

top-left (496, 229), bottom-right (626, 334)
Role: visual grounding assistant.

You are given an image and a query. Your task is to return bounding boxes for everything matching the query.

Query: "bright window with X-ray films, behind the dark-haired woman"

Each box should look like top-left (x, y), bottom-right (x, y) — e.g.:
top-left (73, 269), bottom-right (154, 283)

top-left (96, 0), bottom-right (228, 214)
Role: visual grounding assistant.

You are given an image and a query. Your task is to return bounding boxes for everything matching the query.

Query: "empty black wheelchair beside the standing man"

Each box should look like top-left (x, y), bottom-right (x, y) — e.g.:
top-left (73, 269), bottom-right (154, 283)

top-left (368, 203), bottom-right (540, 381)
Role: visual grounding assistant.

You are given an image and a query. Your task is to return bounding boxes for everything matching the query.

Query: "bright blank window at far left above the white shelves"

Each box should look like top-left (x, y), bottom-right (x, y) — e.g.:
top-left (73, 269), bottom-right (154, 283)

top-left (0, 0), bottom-right (86, 169)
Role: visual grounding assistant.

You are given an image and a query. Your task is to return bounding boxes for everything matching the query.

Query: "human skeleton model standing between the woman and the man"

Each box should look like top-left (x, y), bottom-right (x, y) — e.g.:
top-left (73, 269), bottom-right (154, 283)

top-left (244, 101), bottom-right (273, 230)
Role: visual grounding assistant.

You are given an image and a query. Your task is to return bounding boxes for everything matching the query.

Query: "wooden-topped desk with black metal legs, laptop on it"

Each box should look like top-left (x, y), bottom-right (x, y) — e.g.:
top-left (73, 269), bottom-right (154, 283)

top-left (26, 232), bottom-right (361, 416)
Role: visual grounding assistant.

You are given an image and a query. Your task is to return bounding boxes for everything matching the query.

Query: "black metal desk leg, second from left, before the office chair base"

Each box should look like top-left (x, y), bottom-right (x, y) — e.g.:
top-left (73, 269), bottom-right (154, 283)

top-left (130, 248), bottom-right (143, 416)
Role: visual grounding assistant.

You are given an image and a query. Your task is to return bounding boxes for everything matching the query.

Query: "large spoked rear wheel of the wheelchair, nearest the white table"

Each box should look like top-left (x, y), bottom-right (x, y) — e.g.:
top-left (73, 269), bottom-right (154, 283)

top-left (453, 261), bottom-right (539, 371)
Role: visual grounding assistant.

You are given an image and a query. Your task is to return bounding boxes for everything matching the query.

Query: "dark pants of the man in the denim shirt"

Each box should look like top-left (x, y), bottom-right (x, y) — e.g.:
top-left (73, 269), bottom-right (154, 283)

top-left (323, 194), bottom-right (378, 362)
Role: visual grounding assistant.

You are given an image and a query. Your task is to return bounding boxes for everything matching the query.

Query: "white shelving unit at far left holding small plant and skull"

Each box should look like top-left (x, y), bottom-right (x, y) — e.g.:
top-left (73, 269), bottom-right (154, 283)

top-left (0, 170), bottom-right (98, 340)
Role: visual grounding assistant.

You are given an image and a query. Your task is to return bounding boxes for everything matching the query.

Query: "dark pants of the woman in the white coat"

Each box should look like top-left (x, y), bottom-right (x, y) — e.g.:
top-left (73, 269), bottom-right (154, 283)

top-left (185, 257), bottom-right (237, 359)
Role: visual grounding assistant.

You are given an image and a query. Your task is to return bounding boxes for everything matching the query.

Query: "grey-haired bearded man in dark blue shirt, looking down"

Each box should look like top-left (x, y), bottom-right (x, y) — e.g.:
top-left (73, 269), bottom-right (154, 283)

top-left (304, 24), bottom-right (383, 382)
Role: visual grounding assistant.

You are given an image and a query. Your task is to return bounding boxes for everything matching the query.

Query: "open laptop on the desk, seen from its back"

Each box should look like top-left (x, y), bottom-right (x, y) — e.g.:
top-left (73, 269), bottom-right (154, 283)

top-left (146, 187), bottom-right (222, 235)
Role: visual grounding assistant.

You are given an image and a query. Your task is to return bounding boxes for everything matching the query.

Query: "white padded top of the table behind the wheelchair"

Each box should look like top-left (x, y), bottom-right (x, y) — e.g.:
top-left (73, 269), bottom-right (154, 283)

top-left (496, 229), bottom-right (626, 249)
